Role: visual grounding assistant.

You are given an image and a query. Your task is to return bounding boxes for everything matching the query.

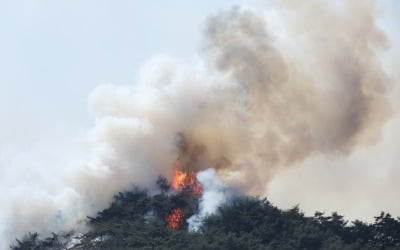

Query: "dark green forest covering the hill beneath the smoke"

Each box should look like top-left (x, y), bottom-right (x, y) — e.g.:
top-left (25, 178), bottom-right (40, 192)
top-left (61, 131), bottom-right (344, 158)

top-left (11, 178), bottom-right (400, 250)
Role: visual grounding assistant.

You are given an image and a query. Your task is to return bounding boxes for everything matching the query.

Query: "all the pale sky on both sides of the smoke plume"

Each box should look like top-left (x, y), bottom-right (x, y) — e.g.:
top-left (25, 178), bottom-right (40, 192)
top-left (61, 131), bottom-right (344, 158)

top-left (0, 0), bottom-right (400, 249)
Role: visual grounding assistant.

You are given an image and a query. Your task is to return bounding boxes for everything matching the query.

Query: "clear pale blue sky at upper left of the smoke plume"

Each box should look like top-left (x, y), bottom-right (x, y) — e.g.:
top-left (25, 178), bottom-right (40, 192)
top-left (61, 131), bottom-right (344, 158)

top-left (0, 0), bottom-right (247, 147)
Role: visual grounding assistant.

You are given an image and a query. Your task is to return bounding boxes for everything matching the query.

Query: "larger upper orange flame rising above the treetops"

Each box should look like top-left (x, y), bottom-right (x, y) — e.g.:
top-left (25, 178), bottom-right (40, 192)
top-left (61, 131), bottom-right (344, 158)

top-left (171, 167), bottom-right (203, 195)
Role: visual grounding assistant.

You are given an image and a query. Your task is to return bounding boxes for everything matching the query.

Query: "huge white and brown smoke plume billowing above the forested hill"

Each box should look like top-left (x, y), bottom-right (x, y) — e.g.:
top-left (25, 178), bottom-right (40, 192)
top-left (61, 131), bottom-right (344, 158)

top-left (3, 0), bottom-right (400, 248)
